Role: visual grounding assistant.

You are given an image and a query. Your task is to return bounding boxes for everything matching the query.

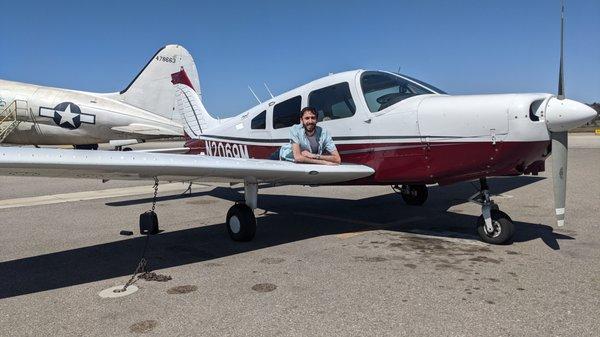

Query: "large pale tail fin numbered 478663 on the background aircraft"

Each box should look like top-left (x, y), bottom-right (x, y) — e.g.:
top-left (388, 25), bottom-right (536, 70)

top-left (115, 45), bottom-right (201, 123)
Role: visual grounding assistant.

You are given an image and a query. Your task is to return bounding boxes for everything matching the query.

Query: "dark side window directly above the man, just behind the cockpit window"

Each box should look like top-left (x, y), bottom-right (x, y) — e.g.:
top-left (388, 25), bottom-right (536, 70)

top-left (308, 82), bottom-right (356, 121)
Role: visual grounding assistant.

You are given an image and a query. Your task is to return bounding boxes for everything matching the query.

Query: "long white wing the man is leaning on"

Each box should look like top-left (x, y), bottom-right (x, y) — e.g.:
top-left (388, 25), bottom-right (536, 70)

top-left (0, 147), bottom-right (374, 185)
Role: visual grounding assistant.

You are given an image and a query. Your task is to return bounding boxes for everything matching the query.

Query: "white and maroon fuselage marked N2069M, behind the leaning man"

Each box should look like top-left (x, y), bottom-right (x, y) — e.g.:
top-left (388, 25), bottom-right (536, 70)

top-left (186, 70), bottom-right (552, 184)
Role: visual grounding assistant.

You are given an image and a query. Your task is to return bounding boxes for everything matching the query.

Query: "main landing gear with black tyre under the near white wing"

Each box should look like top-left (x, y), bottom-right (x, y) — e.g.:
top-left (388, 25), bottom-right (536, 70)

top-left (226, 181), bottom-right (258, 241)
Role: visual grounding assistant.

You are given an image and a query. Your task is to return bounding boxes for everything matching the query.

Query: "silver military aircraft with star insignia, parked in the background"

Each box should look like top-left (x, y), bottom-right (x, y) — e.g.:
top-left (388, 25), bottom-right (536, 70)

top-left (0, 45), bottom-right (200, 149)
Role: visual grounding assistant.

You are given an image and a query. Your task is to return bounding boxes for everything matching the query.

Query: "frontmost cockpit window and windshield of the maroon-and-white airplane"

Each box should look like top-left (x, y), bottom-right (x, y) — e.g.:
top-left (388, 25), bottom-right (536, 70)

top-left (360, 71), bottom-right (434, 112)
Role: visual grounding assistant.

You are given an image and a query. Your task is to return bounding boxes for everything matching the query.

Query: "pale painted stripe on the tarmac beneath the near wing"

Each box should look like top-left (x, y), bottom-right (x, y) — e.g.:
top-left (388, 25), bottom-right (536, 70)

top-left (0, 183), bottom-right (205, 209)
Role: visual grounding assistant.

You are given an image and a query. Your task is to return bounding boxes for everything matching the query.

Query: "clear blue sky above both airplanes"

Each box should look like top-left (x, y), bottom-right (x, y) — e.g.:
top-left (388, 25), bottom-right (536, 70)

top-left (0, 0), bottom-right (600, 116)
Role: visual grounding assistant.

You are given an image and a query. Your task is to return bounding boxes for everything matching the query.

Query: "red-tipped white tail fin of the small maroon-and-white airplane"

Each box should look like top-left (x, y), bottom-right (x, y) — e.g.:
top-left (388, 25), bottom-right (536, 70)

top-left (171, 69), bottom-right (219, 139)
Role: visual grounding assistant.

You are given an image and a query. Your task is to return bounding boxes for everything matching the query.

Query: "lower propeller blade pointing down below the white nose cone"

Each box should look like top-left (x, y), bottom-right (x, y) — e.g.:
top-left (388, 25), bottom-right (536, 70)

top-left (550, 131), bottom-right (568, 227)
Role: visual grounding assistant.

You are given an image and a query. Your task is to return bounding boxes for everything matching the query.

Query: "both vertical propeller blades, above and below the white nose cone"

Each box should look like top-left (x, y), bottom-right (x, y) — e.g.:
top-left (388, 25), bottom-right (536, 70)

top-left (550, 0), bottom-right (569, 227)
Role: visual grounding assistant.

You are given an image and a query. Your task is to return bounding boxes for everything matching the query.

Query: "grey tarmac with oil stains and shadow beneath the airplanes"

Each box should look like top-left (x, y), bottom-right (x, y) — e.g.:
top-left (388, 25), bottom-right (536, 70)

top-left (0, 136), bottom-right (600, 336)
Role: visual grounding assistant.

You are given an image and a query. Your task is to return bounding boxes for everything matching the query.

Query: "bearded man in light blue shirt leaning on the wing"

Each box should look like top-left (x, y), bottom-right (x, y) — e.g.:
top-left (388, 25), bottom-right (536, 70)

top-left (279, 107), bottom-right (342, 165)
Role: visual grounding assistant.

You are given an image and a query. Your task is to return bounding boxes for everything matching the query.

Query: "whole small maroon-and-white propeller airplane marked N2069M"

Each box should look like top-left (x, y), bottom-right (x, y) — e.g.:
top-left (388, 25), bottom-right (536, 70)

top-left (0, 5), bottom-right (597, 244)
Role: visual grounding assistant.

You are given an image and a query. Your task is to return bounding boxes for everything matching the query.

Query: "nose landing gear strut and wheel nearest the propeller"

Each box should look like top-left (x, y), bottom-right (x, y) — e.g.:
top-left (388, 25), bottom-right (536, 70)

top-left (470, 178), bottom-right (515, 245)
